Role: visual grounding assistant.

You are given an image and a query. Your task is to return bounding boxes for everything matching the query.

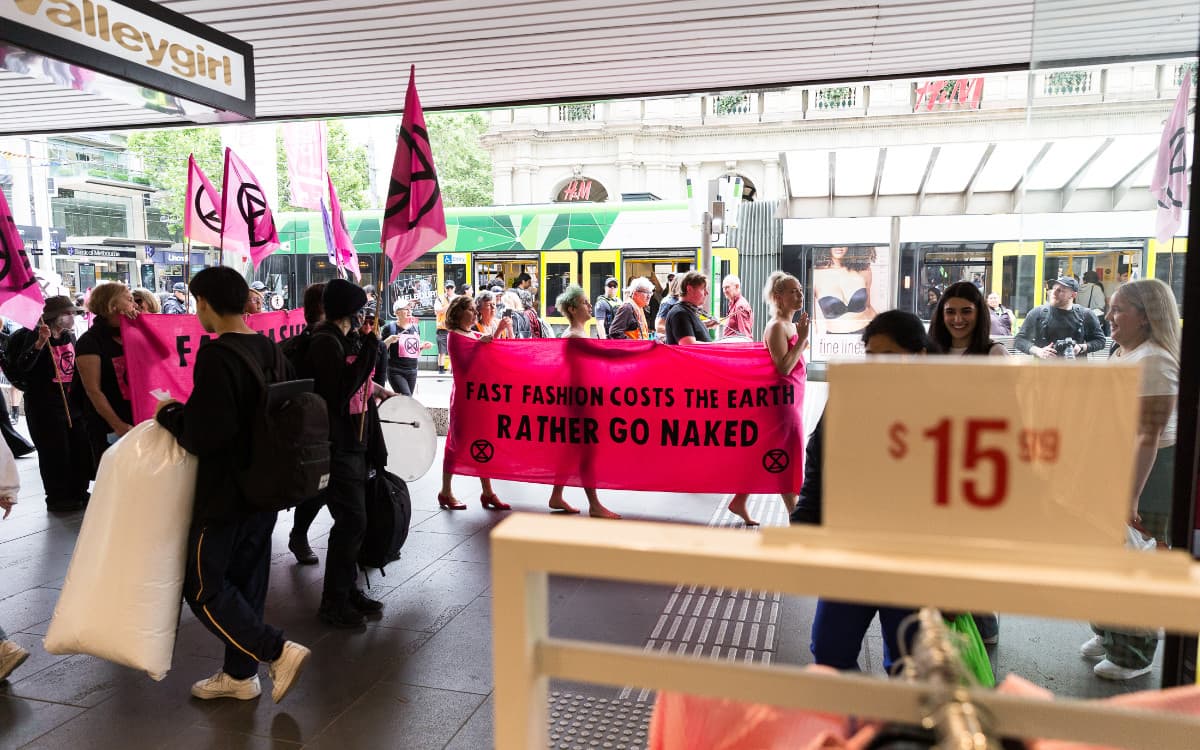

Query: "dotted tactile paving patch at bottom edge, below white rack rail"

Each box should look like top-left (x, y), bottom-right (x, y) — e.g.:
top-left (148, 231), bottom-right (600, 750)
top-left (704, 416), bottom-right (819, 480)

top-left (548, 691), bottom-right (653, 750)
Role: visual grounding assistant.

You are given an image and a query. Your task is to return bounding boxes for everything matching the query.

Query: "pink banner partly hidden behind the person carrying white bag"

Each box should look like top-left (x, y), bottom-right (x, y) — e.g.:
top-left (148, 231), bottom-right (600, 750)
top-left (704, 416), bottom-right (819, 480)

top-left (121, 310), bottom-right (305, 422)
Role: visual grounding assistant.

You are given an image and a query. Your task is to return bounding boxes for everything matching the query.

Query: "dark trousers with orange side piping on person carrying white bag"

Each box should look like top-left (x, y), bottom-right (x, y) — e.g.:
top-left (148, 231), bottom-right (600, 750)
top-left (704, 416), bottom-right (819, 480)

top-left (184, 512), bottom-right (283, 679)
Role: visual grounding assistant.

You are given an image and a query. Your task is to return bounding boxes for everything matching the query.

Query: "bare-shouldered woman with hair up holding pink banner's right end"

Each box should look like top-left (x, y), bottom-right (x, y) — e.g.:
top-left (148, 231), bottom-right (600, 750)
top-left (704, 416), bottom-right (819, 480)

top-left (730, 271), bottom-right (820, 527)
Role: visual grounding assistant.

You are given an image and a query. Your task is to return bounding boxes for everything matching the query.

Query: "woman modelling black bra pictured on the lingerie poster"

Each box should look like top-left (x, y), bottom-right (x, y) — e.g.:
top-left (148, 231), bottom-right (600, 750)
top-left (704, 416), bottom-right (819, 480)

top-left (812, 247), bottom-right (875, 334)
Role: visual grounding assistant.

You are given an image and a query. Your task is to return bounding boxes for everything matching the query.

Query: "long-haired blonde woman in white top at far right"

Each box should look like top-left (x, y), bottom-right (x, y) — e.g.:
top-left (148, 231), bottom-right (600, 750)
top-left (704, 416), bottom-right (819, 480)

top-left (1079, 278), bottom-right (1181, 680)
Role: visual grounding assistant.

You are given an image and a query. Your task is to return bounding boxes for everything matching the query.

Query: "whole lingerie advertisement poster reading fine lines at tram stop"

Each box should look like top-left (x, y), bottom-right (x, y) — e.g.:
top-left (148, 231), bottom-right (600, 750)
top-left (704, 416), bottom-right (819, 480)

top-left (802, 245), bottom-right (892, 362)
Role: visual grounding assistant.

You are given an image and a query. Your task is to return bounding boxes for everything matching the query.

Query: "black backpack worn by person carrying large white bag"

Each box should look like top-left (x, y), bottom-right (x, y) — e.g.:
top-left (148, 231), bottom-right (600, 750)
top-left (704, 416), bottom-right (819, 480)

top-left (215, 338), bottom-right (330, 511)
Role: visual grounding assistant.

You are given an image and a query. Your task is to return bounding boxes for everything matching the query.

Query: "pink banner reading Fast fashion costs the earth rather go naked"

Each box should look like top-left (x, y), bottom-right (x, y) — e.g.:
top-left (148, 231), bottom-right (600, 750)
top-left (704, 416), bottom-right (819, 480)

top-left (444, 335), bottom-right (804, 493)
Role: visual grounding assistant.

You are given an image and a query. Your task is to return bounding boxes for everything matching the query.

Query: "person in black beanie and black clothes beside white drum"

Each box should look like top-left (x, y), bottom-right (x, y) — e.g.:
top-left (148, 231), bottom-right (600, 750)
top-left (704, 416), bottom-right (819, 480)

top-left (301, 278), bottom-right (391, 628)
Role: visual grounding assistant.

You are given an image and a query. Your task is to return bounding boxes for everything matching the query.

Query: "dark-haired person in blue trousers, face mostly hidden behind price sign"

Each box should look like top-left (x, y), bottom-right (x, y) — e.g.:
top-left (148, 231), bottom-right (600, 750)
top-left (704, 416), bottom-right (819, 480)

top-left (806, 310), bottom-right (937, 671)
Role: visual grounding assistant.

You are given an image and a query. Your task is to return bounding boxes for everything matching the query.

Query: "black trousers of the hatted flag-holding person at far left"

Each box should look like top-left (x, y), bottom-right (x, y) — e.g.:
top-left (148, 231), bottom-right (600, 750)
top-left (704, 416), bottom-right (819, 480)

top-left (25, 394), bottom-right (95, 508)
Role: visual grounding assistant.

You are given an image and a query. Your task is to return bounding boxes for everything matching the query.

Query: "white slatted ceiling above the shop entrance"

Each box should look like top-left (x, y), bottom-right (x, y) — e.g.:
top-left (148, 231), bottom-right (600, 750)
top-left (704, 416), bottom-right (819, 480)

top-left (0, 0), bottom-right (1200, 132)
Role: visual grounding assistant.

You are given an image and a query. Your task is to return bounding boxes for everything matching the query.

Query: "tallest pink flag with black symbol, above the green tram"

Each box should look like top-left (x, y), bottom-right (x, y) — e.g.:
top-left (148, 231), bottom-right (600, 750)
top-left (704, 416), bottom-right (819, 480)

top-left (380, 65), bottom-right (446, 281)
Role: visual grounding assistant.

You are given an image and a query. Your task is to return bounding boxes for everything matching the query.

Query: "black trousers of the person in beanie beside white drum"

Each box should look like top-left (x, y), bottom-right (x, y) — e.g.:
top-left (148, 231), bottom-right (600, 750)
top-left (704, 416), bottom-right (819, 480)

top-left (320, 449), bottom-right (367, 606)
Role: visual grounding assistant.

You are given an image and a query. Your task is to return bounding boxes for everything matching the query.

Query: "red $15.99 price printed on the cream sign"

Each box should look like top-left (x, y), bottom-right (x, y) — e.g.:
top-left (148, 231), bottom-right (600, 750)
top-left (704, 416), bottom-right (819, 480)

top-left (888, 418), bottom-right (1060, 508)
